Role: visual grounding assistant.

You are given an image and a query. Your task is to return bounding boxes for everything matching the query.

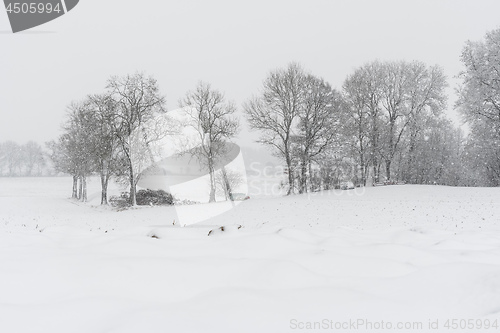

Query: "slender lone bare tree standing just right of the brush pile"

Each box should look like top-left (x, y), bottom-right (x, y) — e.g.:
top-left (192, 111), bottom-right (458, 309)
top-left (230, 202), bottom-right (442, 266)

top-left (179, 82), bottom-right (239, 202)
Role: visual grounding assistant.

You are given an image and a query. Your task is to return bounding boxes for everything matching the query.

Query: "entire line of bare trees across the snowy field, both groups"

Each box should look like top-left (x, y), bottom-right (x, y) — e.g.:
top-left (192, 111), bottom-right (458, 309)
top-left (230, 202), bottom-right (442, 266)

top-left (25, 30), bottom-right (500, 204)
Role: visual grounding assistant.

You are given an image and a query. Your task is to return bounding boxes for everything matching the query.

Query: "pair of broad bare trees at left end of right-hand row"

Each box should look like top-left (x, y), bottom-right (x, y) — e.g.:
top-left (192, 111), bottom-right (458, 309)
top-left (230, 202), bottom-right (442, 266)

top-left (244, 63), bottom-right (343, 194)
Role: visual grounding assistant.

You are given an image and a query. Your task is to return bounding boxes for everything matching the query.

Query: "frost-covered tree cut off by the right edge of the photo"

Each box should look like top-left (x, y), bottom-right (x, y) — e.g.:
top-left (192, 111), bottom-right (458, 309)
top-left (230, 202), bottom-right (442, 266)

top-left (455, 29), bottom-right (500, 186)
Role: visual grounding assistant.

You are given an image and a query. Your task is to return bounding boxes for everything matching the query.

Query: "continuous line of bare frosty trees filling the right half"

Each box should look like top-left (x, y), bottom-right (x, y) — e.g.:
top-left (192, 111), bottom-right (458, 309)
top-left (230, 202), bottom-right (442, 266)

top-left (244, 29), bottom-right (500, 194)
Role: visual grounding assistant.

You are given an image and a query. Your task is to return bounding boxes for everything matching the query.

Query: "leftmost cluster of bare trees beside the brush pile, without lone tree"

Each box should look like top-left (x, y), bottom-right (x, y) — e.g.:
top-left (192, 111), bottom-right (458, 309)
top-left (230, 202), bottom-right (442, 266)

top-left (48, 74), bottom-right (168, 205)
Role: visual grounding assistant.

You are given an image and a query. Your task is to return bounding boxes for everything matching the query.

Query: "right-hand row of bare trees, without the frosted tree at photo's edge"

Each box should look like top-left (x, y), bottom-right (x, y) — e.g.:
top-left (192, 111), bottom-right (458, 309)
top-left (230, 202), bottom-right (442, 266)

top-left (244, 61), bottom-right (459, 194)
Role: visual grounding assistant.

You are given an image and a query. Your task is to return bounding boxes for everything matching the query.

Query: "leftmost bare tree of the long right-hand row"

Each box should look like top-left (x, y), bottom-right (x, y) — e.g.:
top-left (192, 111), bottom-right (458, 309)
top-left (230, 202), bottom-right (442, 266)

top-left (244, 63), bottom-right (305, 195)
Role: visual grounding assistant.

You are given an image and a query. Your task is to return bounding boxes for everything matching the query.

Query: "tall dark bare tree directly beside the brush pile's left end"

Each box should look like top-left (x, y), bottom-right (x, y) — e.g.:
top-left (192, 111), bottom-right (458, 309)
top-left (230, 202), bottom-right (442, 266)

top-left (107, 73), bottom-right (168, 206)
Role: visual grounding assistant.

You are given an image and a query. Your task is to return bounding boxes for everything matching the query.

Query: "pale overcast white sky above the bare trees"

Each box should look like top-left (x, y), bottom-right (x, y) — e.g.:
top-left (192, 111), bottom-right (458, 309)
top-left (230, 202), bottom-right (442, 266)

top-left (0, 0), bottom-right (500, 143)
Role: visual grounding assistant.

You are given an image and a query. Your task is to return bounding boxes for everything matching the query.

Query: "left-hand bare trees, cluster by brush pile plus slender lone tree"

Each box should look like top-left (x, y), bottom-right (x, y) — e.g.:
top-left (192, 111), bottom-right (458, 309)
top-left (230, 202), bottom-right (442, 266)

top-left (47, 73), bottom-right (239, 205)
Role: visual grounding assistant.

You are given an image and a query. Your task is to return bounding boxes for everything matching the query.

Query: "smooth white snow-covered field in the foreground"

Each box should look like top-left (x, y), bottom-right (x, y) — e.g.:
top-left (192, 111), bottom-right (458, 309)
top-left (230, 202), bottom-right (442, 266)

top-left (0, 178), bottom-right (500, 333)
